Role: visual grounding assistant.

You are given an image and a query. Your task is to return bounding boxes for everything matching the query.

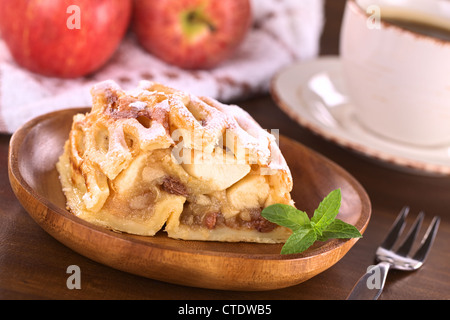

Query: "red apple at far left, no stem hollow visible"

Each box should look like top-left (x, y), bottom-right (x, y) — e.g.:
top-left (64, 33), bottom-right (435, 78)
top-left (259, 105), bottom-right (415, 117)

top-left (0, 0), bottom-right (132, 78)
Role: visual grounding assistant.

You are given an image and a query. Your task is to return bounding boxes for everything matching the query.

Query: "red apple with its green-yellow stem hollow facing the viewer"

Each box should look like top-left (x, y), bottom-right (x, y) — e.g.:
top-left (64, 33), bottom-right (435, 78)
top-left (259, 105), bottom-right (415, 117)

top-left (132, 0), bottom-right (251, 69)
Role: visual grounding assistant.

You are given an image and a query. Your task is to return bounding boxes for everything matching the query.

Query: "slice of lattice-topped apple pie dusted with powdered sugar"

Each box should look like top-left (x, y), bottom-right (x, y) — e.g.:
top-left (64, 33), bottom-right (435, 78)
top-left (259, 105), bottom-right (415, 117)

top-left (57, 81), bottom-right (293, 243)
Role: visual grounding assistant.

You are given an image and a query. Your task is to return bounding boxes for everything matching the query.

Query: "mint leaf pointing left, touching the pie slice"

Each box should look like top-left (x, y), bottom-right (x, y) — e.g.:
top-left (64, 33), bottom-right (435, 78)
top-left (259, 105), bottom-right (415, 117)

top-left (261, 204), bottom-right (309, 231)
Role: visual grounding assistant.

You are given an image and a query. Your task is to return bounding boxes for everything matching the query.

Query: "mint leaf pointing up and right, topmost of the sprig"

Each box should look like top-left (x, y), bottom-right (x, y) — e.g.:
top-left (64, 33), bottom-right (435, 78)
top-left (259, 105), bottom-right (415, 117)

top-left (311, 189), bottom-right (341, 235)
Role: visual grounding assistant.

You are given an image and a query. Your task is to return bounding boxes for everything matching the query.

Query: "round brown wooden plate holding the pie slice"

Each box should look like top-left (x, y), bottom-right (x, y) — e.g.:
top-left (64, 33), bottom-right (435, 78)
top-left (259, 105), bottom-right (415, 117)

top-left (8, 108), bottom-right (371, 291)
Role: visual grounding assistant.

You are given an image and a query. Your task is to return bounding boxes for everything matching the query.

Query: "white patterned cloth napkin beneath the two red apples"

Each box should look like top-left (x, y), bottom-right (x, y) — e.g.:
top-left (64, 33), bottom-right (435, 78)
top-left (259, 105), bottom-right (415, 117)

top-left (0, 0), bottom-right (324, 133)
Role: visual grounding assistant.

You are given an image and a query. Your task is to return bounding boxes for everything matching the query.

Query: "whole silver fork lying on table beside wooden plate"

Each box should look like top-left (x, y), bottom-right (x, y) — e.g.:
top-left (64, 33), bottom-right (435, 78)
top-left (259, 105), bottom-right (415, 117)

top-left (347, 207), bottom-right (440, 300)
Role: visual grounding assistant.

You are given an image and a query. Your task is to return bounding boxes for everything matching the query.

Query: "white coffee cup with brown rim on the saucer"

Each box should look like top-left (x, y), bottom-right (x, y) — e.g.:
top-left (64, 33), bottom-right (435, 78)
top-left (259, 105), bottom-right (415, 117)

top-left (340, 0), bottom-right (450, 147)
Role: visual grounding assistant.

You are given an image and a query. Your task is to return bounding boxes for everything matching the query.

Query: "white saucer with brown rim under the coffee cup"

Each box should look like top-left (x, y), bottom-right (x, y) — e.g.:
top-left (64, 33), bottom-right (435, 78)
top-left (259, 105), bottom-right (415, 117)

top-left (271, 56), bottom-right (450, 176)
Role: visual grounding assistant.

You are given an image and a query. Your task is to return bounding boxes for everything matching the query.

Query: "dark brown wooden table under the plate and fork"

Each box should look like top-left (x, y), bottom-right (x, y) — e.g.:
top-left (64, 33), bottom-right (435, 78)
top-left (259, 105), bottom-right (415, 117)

top-left (0, 0), bottom-right (450, 300)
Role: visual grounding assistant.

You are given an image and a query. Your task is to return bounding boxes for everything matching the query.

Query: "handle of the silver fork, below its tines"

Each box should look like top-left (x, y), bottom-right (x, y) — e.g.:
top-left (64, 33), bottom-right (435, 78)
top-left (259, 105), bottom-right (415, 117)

top-left (347, 262), bottom-right (391, 300)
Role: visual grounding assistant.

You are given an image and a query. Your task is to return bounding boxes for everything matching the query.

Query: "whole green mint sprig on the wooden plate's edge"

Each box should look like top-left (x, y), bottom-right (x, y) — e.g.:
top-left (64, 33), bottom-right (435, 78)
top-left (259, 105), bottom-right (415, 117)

top-left (261, 189), bottom-right (362, 254)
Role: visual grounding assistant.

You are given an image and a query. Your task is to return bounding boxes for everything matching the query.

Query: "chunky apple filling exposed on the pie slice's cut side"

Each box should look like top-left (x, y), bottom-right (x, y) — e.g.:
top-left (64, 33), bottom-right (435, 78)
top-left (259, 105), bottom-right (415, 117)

top-left (104, 145), bottom-right (276, 232)
